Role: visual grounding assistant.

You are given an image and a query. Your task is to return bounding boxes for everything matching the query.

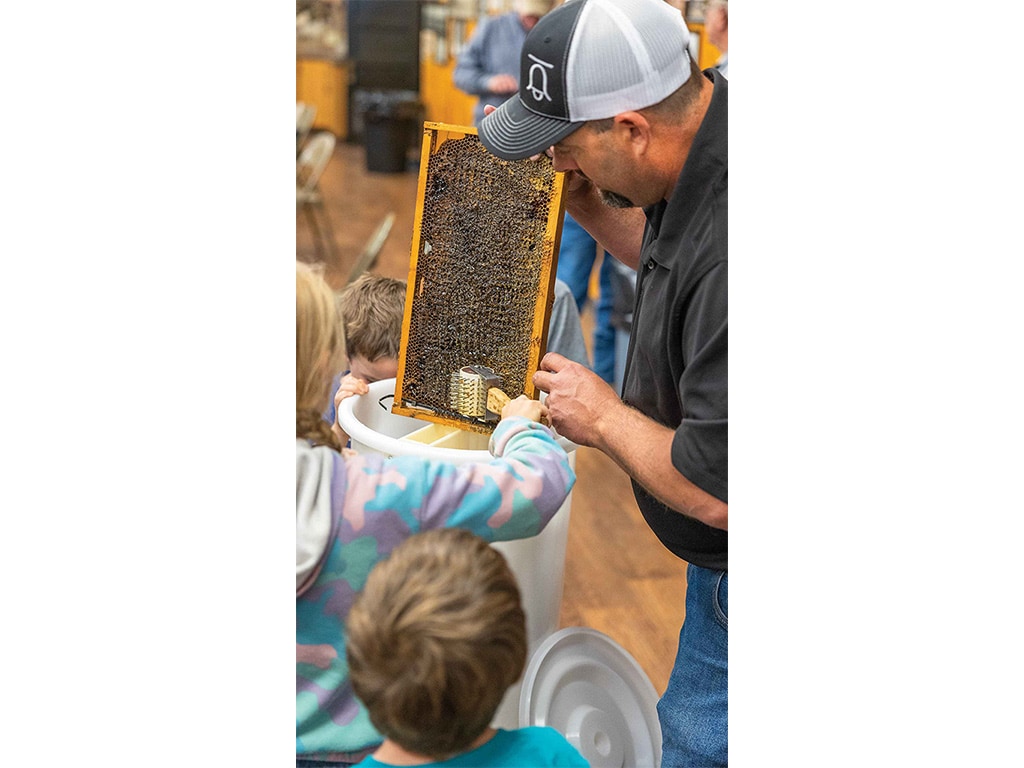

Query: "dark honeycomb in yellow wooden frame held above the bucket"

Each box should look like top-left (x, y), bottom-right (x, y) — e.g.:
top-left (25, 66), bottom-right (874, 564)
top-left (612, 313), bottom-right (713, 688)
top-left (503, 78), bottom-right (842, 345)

top-left (391, 123), bottom-right (563, 431)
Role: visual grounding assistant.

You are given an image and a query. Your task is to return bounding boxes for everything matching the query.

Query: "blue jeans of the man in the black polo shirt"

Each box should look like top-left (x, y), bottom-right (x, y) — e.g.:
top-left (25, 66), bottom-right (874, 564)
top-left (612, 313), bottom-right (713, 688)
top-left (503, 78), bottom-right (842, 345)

top-left (657, 565), bottom-right (729, 768)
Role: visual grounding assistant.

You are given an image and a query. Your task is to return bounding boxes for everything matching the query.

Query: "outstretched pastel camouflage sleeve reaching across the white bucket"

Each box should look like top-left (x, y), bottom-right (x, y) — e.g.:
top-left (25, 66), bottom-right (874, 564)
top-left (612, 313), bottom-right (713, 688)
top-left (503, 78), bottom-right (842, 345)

top-left (343, 418), bottom-right (575, 541)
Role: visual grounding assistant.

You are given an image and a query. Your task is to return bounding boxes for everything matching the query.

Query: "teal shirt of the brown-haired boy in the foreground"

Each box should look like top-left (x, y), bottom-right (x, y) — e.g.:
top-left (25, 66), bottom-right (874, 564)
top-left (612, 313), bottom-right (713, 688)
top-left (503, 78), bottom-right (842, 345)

top-left (356, 725), bottom-right (590, 768)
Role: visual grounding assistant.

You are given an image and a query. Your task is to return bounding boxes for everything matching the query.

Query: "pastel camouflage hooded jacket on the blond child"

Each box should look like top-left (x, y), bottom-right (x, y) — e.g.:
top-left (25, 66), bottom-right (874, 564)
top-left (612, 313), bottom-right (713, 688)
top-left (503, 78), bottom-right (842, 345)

top-left (295, 418), bottom-right (575, 760)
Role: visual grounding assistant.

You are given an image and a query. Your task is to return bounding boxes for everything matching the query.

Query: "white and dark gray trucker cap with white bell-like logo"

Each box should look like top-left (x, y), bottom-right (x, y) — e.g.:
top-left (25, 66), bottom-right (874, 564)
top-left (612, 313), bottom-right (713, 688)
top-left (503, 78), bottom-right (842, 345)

top-left (478, 0), bottom-right (690, 160)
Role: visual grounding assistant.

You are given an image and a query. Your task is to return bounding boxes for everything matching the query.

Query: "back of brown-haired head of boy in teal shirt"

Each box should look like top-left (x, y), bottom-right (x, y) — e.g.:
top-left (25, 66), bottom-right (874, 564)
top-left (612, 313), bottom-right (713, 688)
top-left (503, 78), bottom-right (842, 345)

top-left (346, 528), bottom-right (526, 760)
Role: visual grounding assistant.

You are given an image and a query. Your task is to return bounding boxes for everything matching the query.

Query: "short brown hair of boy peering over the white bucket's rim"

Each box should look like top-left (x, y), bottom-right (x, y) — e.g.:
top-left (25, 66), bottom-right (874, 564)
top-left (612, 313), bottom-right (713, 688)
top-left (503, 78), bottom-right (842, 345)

top-left (341, 274), bottom-right (407, 362)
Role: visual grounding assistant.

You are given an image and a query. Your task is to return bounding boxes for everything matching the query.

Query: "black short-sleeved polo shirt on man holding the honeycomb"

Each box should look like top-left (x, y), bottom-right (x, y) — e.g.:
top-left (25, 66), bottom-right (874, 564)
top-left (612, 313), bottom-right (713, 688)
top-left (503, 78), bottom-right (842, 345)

top-left (623, 70), bottom-right (729, 569)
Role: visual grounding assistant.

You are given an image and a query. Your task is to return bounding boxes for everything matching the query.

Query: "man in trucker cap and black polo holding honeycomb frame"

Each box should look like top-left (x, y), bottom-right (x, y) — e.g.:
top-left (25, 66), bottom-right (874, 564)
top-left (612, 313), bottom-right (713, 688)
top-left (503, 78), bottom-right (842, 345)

top-left (479, 0), bottom-right (729, 767)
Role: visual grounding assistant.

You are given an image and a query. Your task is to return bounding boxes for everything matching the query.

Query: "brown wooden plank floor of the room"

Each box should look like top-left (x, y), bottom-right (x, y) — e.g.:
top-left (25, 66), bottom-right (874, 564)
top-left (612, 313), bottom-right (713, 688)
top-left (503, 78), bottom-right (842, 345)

top-left (296, 142), bottom-right (686, 694)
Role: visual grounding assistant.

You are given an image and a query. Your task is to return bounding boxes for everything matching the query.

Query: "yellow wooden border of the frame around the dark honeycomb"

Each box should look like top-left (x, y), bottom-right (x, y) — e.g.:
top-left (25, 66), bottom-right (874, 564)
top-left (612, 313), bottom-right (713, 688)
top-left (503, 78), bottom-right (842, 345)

top-left (391, 122), bottom-right (565, 432)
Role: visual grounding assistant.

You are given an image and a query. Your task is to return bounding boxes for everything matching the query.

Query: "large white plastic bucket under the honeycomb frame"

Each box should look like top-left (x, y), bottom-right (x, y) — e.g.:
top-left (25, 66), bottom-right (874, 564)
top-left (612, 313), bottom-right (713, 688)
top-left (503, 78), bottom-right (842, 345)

top-left (338, 379), bottom-right (577, 729)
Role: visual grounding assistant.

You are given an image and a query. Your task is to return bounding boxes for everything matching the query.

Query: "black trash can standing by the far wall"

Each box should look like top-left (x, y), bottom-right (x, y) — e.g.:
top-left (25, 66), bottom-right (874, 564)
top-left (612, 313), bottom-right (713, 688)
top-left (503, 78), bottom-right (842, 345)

top-left (359, 91), bottom-right (423, 173)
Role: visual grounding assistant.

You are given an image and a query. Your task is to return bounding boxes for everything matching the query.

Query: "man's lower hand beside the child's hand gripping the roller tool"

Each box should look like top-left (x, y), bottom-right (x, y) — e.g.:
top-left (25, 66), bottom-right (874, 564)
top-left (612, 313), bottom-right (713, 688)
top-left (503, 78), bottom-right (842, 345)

top-left (534, 352), bottom-right (623, 447)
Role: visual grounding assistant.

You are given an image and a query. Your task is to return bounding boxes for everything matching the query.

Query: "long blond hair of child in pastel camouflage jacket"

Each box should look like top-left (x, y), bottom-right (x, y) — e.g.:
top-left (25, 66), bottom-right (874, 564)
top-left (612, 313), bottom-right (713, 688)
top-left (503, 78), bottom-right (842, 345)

top-left (295, 261), bottom-right (345, 444)
